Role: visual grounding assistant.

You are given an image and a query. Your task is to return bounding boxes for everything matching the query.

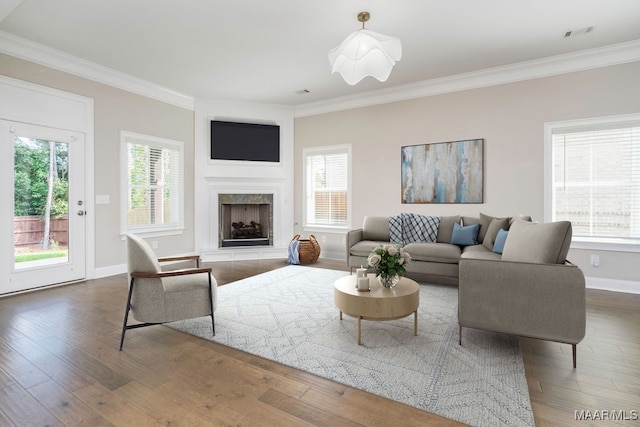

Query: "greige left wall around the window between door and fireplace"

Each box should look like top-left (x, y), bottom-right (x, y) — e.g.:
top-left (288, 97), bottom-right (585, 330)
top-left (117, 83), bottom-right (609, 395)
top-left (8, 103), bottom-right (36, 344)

top-left (0, 54), bottom-right (194, 272)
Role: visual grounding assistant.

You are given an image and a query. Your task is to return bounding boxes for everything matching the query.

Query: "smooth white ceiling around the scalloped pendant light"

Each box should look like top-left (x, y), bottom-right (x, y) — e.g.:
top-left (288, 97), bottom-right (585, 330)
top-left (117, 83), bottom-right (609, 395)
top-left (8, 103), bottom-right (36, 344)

top-left (0, 0), bottom-right (640, 106)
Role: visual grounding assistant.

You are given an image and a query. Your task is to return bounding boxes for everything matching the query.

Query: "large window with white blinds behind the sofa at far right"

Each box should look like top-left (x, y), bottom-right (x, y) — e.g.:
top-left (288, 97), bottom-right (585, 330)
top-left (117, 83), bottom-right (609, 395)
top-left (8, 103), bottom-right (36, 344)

top-left (547, 116), bottom-right (640, 245)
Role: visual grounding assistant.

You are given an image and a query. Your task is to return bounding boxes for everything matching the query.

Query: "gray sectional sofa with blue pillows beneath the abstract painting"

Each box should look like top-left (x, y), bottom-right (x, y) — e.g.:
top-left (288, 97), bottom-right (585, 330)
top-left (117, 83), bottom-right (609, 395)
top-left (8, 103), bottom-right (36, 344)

top-left (346, 214), bottom-right (586, 368)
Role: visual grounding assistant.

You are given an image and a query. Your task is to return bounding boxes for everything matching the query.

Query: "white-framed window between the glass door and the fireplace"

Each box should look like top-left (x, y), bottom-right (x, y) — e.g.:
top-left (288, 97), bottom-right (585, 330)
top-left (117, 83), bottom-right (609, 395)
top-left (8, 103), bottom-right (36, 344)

top-left (121, 132), bottom-right (184, 235)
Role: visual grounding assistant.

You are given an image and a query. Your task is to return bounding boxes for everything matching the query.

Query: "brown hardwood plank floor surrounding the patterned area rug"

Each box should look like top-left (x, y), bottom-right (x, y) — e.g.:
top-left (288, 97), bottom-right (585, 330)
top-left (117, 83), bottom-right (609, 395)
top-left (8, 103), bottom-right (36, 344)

top-left (0, 260), bottom-right (640, 426)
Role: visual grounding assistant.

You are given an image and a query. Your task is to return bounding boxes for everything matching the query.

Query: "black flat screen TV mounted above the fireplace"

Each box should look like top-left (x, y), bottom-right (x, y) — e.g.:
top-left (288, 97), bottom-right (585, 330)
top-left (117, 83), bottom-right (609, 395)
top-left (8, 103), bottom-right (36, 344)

top-left (211, 120), bottom-right (280, 162)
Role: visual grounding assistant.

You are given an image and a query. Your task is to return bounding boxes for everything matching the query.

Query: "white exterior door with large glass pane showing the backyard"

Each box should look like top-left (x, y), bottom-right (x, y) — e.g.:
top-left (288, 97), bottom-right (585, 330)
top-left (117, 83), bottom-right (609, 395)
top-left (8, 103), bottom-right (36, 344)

top-left (0, 120), bottom-right (87, 294)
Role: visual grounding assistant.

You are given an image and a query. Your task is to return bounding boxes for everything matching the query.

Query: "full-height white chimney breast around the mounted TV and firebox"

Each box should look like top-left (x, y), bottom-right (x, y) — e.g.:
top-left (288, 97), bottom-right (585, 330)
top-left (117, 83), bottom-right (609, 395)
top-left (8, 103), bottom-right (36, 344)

top-left (194, 99), bottom-right (295, 261)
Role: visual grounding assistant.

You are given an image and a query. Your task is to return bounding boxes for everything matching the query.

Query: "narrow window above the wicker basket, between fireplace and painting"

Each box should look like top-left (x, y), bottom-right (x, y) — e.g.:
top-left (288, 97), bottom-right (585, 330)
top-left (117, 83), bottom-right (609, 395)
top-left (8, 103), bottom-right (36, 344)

top-left (303, 145), bottom-right (351, 229)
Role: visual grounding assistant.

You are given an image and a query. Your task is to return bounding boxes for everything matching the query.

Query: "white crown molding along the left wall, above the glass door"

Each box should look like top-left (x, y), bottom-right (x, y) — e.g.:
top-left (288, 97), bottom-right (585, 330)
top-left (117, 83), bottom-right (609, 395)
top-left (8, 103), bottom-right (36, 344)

top-left (0, 31), bottom-right (195, 111)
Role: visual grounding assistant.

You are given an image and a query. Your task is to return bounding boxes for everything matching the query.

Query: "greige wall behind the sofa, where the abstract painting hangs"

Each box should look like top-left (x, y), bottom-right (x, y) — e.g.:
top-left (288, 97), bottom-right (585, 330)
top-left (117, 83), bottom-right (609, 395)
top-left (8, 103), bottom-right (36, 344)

top-left (295, 62), bottom-right (640, 288)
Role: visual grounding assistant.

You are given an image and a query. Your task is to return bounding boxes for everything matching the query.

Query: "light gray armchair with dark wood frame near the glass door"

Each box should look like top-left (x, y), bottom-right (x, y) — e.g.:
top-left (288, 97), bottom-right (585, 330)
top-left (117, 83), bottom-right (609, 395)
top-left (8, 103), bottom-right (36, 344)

top-left (120, 234), bottom-right (218, 350)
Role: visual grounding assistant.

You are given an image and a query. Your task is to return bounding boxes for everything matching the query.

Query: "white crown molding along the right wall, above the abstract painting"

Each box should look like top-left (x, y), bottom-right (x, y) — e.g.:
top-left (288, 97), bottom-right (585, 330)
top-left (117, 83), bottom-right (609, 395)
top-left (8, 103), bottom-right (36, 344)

top-left (294, 40), bottom-right (640, 117)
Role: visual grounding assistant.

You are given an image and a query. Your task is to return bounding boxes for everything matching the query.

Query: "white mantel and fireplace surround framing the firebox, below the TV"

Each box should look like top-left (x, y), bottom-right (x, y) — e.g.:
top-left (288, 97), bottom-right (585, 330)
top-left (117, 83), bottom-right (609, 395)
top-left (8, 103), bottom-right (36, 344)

top-left (201, 177), bottom-right (292, 261)
